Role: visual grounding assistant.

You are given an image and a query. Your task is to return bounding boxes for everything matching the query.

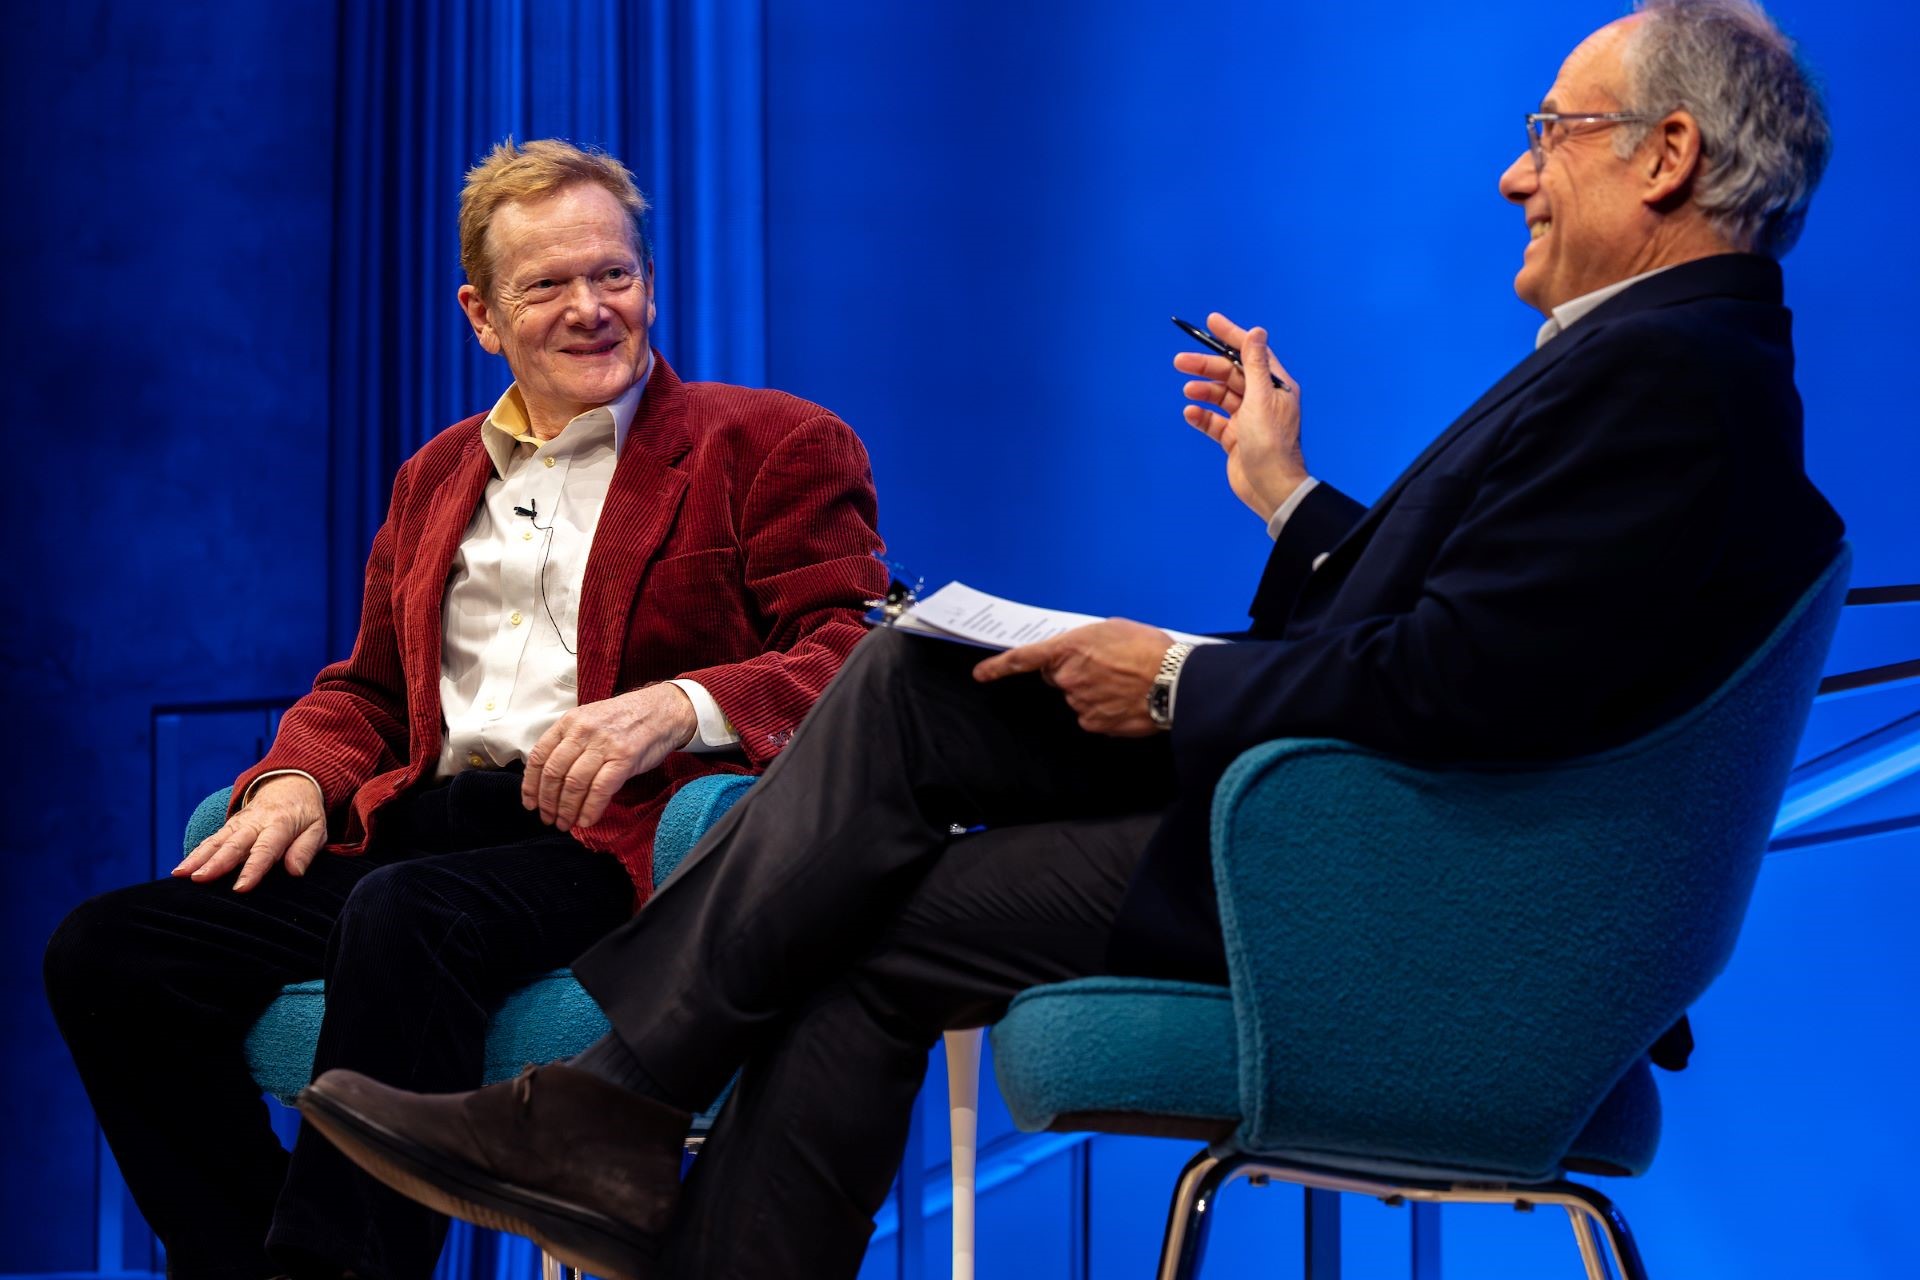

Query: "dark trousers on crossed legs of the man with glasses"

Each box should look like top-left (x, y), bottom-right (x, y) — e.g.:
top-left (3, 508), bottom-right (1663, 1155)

top-left (574, 631), bottom-right (1173, 1280)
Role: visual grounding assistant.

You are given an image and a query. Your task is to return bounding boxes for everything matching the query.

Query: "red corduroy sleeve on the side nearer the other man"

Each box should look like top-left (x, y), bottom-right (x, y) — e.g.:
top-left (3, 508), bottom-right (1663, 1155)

top-left (682, 415), bottom-right (887, 766)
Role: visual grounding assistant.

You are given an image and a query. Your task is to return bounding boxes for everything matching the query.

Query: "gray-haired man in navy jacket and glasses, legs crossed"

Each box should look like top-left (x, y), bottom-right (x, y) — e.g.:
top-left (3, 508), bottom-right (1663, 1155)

top-left (291, 0), bottom-right (1841, 1278)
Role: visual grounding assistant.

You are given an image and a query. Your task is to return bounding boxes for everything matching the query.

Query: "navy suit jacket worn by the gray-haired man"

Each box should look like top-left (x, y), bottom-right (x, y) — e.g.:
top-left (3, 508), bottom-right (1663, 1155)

top-left (1112, 253), bottom-right (1841, 983)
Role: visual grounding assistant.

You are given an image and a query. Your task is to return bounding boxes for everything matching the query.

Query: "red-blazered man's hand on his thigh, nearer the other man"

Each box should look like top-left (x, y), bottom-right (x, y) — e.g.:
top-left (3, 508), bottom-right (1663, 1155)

top-left (520, 683), bottom-right (699, 831)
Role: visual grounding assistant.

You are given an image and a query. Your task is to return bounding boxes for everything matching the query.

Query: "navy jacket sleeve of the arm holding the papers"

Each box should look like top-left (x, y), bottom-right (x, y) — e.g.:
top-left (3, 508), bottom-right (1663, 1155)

top-left (1173, 326), bottom-right (1728, 785)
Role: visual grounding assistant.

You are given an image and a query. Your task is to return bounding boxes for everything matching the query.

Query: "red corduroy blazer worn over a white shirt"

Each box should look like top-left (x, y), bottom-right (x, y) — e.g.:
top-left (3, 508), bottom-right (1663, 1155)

top-left (234, 351), bottom-right (887, 902)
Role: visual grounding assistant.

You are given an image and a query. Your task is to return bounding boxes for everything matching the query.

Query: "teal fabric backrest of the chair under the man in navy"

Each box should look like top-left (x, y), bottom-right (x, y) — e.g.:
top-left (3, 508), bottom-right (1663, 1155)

top-left (1213, 547), bottom-right (1851, 1176)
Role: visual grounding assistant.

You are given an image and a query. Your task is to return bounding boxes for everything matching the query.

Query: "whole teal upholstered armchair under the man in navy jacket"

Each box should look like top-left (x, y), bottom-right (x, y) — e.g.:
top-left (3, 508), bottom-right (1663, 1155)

top-left (993, 549), bottom-right (1849, 1280)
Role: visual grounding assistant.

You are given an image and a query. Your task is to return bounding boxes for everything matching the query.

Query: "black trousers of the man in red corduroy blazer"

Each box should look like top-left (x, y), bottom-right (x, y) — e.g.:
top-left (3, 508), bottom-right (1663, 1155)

top-left (46, 773), bottom-right (634, 1280)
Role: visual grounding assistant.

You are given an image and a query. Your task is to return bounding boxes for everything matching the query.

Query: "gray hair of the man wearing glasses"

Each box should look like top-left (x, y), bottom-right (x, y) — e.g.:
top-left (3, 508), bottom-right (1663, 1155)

top-left (1615, 0), bottom-right (1834, 257)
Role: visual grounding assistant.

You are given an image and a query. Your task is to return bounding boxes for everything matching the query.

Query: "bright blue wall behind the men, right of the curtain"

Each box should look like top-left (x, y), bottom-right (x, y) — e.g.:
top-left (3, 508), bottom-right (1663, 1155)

top-left (768, 0), bottom-right (1920, 628)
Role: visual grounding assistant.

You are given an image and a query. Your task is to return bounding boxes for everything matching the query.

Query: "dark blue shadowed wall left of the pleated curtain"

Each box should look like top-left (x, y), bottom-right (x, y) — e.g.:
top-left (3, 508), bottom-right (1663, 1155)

top-left (0, 0), bottom-right (334, 1272)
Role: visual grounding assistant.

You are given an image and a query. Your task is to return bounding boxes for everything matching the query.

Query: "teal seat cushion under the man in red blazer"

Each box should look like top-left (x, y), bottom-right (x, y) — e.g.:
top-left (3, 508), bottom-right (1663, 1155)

top-left (246, 969), bottom-right (607, 1103)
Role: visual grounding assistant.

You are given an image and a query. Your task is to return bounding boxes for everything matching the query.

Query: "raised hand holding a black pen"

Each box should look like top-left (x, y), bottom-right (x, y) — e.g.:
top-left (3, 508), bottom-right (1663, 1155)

top-left (1173, 311), bottom-right (1308, 520)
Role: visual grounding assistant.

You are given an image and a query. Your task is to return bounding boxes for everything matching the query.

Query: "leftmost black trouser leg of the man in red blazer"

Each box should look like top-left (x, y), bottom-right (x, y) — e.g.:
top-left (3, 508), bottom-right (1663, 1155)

top-left (44, 856), bottom-right (401, 1280)
